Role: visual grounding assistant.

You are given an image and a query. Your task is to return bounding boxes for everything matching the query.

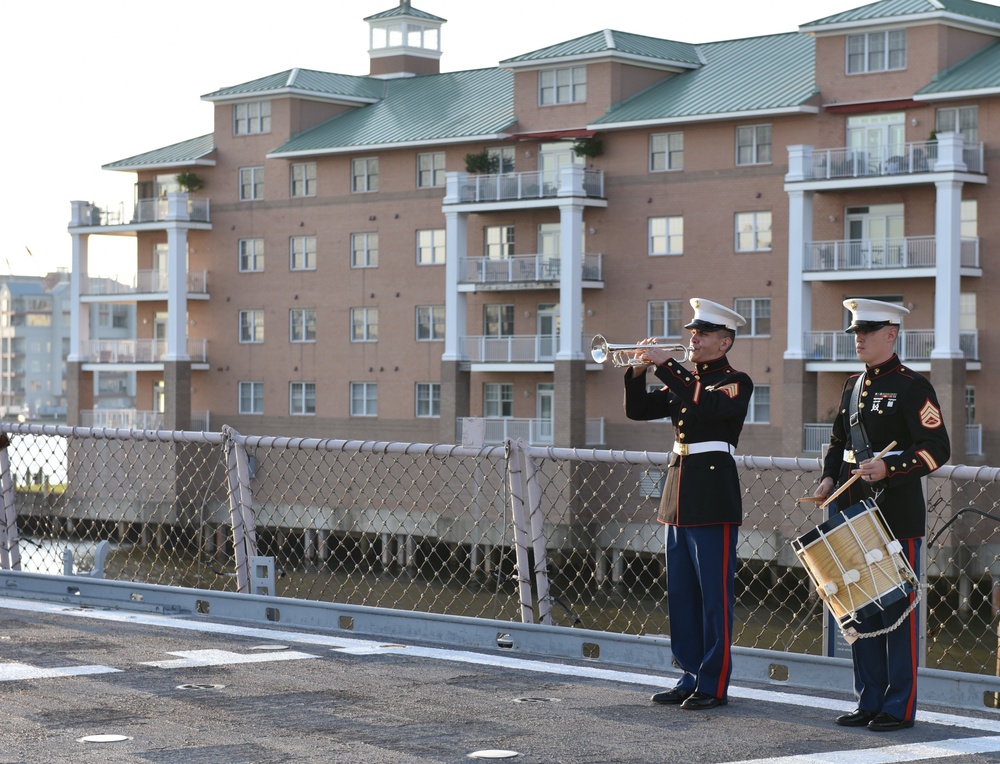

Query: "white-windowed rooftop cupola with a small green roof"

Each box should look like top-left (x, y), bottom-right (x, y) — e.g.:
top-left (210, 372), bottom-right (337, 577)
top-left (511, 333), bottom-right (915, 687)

top-left (365, 0), bottom-right (447, 79)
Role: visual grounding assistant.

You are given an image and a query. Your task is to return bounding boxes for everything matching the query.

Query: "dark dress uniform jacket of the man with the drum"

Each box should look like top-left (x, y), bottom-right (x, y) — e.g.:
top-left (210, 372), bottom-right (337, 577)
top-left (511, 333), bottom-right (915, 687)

top-left (823, 355), bottom-right (951, 539)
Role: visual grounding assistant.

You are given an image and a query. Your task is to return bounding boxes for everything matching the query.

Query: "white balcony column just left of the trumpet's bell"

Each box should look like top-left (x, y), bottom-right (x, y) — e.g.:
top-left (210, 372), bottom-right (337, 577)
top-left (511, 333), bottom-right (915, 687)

top-left (556, 199), bottom-right (583, 361)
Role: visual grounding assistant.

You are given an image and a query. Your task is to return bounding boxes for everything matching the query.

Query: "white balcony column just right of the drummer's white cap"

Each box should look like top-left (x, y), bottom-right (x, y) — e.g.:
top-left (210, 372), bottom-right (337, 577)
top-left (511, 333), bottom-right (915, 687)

top-left (931, 180), bottom-right (963, 358)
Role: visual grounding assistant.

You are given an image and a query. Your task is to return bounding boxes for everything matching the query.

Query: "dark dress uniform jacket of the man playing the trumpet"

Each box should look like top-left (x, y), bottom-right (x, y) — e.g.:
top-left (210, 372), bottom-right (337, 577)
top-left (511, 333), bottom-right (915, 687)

top-left (625, 356), bottom-right (753, 526)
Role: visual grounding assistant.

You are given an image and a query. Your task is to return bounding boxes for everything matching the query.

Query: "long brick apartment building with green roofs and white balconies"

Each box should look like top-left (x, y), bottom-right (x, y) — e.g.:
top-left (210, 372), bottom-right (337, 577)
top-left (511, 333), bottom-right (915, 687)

top-left (68, 0), bottom-right (1000, 462)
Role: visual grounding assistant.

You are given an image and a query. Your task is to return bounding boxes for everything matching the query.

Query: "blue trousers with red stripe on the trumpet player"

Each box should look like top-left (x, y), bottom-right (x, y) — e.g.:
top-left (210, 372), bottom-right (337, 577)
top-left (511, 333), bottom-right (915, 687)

top-left (666, 523), bottom-right (739, 698)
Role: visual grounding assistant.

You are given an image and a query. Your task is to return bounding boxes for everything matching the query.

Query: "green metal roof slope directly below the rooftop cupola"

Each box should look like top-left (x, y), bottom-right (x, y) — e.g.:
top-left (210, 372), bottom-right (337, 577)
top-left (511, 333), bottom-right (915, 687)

top-left (268, 69), bottom-right (516, 157)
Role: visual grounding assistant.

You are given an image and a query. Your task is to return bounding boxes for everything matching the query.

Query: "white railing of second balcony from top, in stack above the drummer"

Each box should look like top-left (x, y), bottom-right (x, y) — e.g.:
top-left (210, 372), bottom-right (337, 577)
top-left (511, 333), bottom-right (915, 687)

top-left (804, 236), bottom-right (979, 272)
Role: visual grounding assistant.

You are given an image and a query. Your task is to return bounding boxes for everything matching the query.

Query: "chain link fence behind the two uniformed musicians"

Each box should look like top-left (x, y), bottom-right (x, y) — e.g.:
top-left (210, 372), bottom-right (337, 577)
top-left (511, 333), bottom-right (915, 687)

top-left (0, 425), bottom-right (1000, 676)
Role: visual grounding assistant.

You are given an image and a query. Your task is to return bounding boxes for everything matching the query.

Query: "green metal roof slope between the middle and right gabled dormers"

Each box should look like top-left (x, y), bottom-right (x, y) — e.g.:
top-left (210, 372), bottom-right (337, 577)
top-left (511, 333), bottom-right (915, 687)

top-left (591, 32), bottom-right (818, 126)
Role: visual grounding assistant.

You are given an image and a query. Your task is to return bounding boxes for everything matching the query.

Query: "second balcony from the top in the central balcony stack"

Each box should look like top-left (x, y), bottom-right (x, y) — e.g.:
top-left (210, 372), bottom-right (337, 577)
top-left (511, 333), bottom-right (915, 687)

top-left (458, 254), bottom-right (604, 291)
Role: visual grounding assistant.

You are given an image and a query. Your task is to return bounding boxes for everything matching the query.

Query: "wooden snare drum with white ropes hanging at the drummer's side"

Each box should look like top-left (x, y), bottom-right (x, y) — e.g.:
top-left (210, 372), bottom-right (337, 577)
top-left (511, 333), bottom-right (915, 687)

top-left (792, 499), bottom-right (917, 627)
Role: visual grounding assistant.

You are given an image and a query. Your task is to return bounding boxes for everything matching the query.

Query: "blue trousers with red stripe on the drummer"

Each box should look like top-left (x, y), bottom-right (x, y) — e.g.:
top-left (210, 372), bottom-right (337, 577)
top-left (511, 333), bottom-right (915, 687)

top-left (851, 538), bottom-right (923, 721)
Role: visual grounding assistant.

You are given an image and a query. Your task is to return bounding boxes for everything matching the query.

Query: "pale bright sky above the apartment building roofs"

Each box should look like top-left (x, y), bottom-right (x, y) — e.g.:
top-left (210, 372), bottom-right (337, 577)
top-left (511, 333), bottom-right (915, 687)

top-left (0, 0), bottom-right (880, 277)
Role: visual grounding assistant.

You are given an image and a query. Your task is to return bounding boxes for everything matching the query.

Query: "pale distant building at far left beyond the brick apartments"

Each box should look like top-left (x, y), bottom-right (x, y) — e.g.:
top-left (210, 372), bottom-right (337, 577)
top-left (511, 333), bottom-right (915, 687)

top-left (0, 271), bottom-right (135, 420)
